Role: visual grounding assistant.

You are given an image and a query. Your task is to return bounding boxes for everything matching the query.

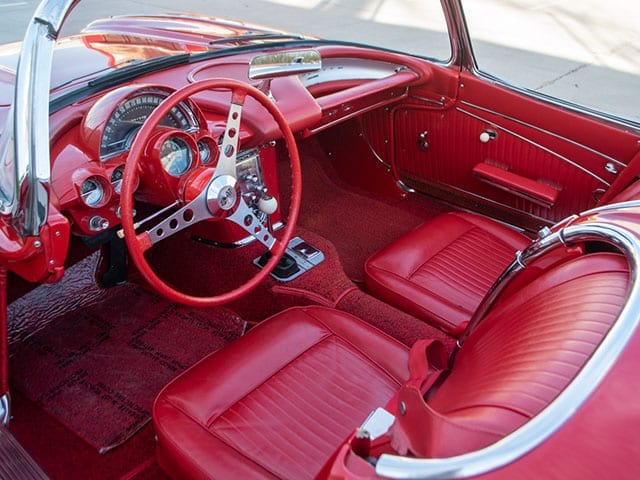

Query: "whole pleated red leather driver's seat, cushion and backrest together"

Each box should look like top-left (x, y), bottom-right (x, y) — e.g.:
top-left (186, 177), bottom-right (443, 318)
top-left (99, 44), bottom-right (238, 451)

top-left (153, 253), bottom-right (629, 479)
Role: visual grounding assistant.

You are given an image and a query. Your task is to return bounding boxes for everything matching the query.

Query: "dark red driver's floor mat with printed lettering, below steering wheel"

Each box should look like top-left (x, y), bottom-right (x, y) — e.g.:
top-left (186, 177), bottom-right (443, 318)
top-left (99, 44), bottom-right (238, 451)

top-left (9, 253), bottom-right (245, 452)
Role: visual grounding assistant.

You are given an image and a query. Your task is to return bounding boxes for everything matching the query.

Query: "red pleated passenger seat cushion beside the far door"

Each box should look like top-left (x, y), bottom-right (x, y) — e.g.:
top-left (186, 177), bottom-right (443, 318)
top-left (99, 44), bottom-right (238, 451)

top-left (365, 212), bottom-right (531, 332)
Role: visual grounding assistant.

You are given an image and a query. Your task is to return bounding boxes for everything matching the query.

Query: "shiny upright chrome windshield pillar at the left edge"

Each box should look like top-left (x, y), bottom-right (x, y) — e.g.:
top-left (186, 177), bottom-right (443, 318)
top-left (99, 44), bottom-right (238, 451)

top-left (0, 0), bottom-right (80, 236)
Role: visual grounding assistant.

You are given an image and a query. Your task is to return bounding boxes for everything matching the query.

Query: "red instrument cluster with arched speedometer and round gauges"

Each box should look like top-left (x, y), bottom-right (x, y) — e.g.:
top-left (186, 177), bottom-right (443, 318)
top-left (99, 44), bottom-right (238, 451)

top-left (52, 85), bottom-right (262, 235)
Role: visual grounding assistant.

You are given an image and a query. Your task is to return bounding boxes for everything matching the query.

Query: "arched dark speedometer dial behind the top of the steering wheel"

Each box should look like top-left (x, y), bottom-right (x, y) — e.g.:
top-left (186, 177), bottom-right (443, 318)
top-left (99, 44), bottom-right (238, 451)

top-left (100, 91), bottom-right (198, 161)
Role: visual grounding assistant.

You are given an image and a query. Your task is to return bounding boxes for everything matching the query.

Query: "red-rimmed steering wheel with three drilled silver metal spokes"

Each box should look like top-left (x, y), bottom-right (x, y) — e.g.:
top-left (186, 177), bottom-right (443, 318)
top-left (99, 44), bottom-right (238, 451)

top-left (120, 79), bottom-right (302, 306)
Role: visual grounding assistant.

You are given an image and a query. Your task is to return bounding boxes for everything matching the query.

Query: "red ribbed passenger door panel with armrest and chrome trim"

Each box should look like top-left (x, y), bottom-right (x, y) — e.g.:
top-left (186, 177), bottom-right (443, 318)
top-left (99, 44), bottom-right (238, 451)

top-left (380, 69), bottom-right (638, 230)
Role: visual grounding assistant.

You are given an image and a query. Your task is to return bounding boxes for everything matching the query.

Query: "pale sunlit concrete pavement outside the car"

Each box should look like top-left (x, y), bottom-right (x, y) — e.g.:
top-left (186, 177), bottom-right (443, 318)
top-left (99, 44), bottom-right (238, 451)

top-left (0, 0), bottom-right (640, 123)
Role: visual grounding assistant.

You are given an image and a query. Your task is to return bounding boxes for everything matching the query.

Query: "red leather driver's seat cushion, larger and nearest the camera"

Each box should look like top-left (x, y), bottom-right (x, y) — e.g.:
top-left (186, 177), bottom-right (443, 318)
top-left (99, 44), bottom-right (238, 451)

top-left (153, 307), bottom-right (408, 479)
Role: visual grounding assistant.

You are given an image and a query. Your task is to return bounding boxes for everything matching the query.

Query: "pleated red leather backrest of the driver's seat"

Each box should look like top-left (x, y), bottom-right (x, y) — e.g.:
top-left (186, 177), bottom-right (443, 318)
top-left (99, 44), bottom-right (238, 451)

top-left (428, 253), bottom-right (629, 457)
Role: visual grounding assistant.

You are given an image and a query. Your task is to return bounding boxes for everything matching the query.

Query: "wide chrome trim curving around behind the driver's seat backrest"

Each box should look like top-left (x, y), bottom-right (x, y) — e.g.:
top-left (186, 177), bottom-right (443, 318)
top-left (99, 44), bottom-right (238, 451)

top-left (376, 221), bottom-right (640, 479)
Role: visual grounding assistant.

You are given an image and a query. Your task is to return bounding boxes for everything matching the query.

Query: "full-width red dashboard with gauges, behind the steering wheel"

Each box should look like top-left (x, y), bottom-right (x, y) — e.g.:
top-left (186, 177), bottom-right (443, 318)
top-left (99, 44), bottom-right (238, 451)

top-left (46, 46), bottom-right (429, 243)
